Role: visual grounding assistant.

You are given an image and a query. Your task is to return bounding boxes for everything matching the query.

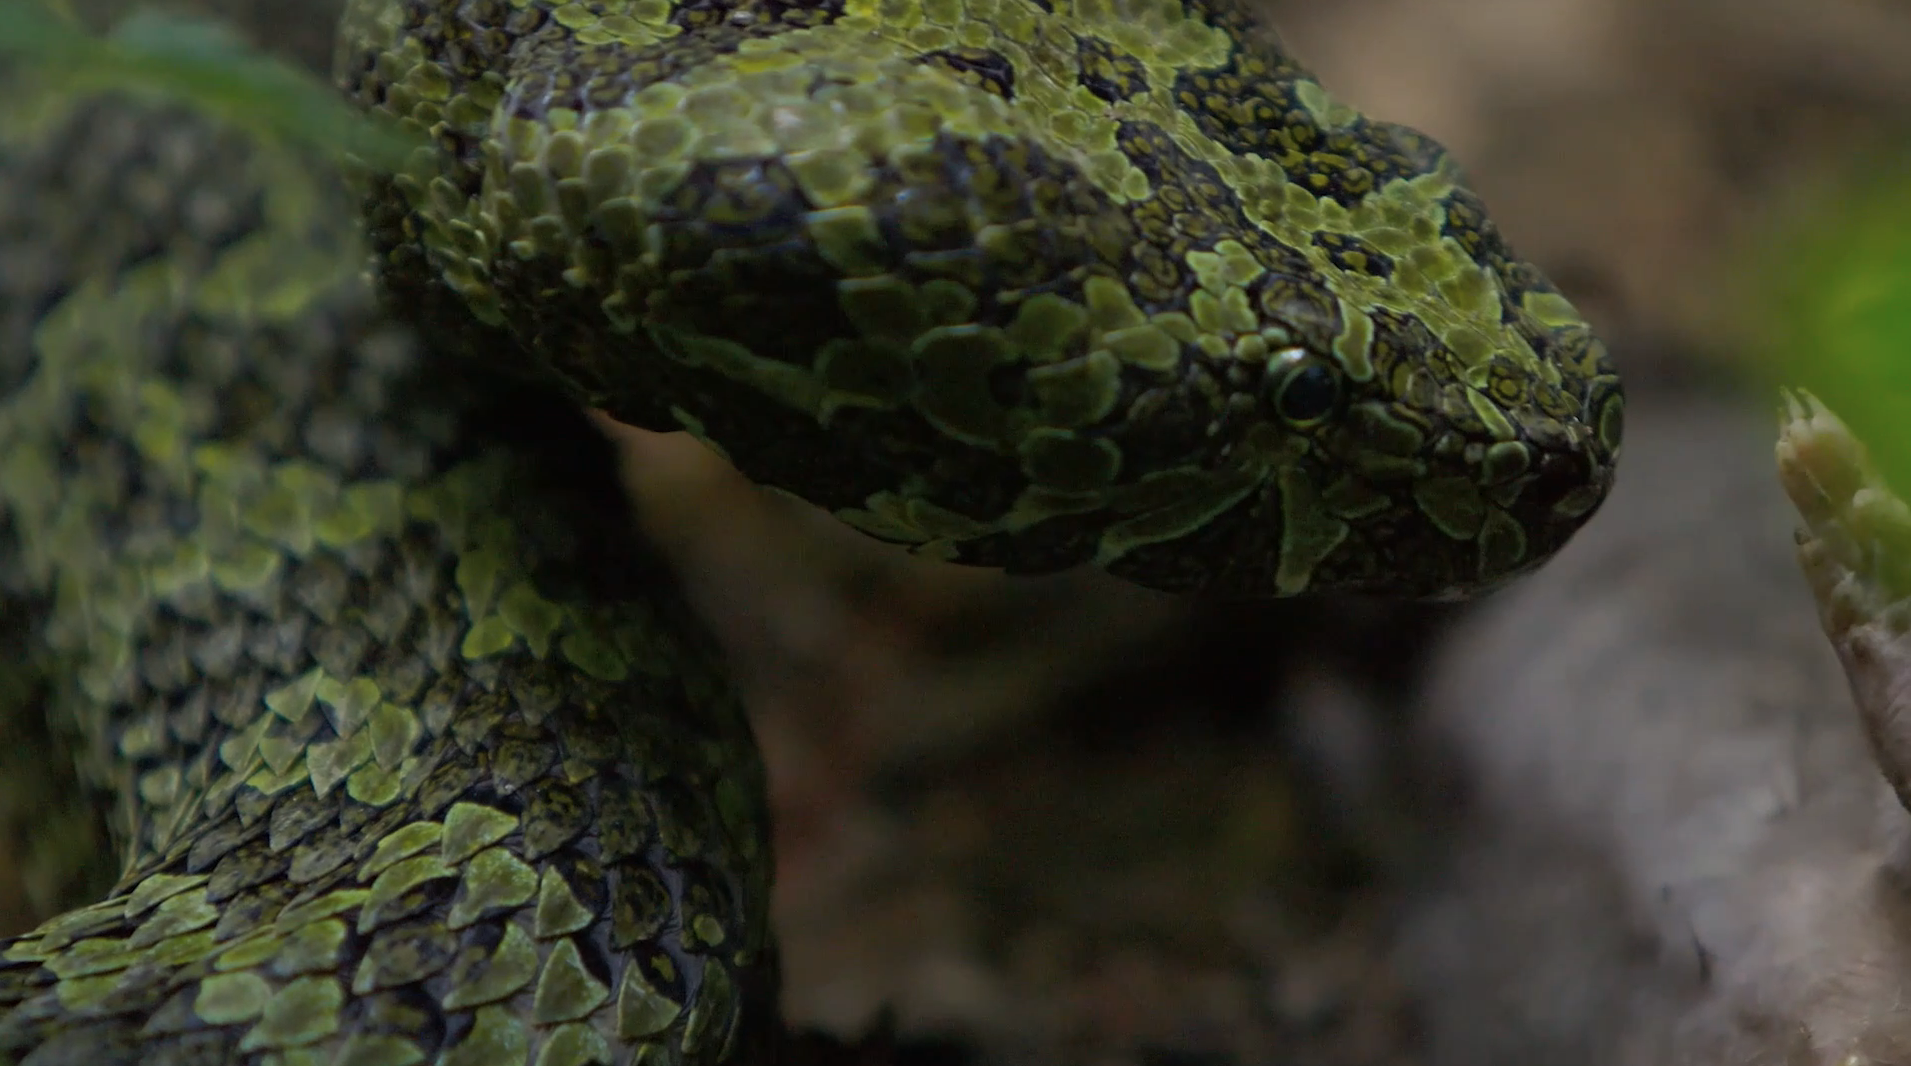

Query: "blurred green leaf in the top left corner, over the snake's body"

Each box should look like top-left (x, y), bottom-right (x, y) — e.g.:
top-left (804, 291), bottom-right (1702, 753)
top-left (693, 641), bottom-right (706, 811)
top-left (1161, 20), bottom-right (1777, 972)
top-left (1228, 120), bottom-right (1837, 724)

top-left (0, 0), bottom-right (428, 170)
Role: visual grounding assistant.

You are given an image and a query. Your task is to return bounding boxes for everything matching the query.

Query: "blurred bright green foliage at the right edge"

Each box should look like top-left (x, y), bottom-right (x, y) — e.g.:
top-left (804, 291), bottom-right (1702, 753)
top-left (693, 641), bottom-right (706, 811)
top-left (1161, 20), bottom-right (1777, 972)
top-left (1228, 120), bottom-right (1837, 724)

top-left (1745, 151), bottom-right (1911, 489)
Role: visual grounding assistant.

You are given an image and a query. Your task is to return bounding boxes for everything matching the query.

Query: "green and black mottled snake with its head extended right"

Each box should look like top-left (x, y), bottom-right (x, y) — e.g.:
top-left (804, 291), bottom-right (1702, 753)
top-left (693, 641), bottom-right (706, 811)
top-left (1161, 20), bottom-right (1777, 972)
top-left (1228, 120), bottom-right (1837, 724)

top-left (0, 0), bottom-right (1624, 1066)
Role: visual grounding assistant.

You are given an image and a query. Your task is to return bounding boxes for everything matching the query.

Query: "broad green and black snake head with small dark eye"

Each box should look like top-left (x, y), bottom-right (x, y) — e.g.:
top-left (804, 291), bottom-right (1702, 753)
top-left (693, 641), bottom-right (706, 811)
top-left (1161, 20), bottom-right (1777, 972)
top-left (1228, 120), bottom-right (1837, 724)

top-left (336, 0), bottom-right (1622, 596)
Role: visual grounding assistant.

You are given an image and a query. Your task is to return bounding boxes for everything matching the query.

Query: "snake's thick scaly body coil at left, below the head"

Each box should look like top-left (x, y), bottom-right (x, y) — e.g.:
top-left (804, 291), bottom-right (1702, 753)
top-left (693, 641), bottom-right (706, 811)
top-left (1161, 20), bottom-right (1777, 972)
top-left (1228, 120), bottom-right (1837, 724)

top-left (0, 94), bottom-right (774, 1066)
